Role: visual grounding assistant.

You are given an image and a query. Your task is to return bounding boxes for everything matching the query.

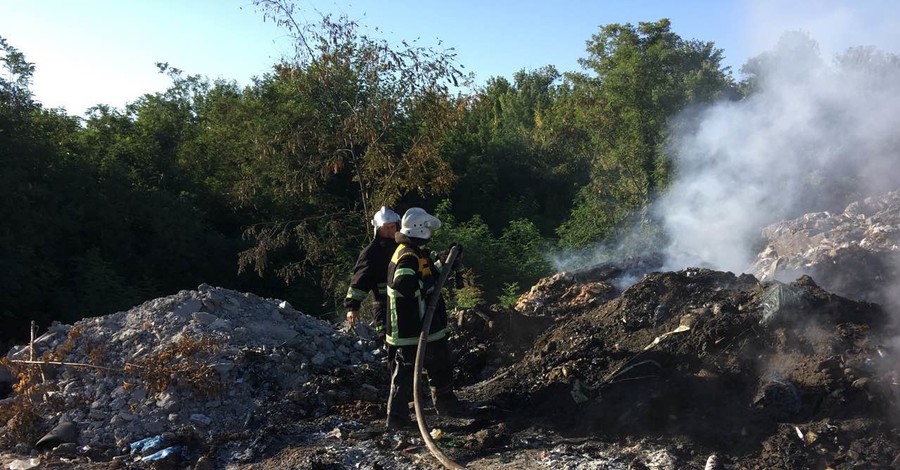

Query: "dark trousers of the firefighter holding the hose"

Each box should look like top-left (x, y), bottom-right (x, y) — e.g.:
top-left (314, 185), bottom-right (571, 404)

top-left (388, 338), bottom-right (455, 423)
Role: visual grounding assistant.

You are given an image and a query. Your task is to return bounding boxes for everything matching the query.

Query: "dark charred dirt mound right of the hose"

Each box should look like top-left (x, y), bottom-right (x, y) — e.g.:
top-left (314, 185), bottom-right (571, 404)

top-left (468, 269), bottom-right (900, 468)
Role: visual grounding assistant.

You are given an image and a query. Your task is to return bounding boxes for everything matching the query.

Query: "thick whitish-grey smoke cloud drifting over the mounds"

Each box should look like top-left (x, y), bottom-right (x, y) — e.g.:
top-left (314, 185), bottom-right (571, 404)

top-left (655, 32), bottom-right (900, 272)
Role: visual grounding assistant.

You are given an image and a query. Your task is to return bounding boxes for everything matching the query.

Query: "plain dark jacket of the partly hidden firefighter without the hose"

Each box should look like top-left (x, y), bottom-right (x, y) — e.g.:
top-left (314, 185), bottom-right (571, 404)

top-left (344, 237), bottom-right (397, 332)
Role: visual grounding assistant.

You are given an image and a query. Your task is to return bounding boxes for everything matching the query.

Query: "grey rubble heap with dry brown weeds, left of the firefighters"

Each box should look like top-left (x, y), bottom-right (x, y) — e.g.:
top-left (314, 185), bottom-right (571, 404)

top-left (0, 284), bottom-right (384, 457)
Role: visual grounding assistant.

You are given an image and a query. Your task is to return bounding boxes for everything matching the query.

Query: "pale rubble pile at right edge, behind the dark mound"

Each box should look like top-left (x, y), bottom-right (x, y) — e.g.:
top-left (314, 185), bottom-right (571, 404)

top-left (752, 191), bottom-right (900, 303)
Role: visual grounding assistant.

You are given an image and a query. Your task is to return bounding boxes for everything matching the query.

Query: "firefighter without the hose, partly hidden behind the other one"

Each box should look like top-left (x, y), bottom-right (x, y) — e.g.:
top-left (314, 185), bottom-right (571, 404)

top-left (344, 206), bottom-right (400, 342)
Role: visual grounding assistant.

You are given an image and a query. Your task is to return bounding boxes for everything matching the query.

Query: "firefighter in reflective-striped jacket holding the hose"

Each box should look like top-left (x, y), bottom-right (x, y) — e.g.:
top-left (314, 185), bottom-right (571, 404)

top-left (385, 207), bottom-right (460, 430)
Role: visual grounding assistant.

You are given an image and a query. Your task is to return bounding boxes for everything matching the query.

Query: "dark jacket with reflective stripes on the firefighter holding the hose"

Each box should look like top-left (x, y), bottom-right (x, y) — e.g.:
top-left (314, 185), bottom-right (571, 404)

top-left (385, 233), bottom-right (447, 346)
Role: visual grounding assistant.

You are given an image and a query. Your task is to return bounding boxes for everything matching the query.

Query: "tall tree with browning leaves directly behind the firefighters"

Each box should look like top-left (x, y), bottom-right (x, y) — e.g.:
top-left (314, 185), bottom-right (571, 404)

top-left (235, 5), bottom-right (464, 304)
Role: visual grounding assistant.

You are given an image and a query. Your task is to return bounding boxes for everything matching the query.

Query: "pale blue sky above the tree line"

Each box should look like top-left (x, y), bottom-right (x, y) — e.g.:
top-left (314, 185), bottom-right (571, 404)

top-left (0, 0), bottom-right (900, 115)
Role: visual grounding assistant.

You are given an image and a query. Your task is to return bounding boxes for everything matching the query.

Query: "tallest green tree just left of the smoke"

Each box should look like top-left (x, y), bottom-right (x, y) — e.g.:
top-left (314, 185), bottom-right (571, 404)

top-left (559, 19), bottom-right (736, 247)
